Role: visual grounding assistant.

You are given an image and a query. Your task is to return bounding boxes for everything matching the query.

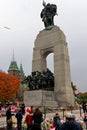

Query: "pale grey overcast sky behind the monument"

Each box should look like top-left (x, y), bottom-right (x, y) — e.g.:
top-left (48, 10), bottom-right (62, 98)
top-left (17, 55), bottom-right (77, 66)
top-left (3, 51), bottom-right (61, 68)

top-left (0, 0), bottom-right (87, 91)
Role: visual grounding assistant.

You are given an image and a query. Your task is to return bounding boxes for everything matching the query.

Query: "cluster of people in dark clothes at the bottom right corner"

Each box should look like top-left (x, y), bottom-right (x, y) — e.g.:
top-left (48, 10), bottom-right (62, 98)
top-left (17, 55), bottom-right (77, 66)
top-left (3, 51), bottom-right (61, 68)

top-left (53, 112), bottom-right (87, 130)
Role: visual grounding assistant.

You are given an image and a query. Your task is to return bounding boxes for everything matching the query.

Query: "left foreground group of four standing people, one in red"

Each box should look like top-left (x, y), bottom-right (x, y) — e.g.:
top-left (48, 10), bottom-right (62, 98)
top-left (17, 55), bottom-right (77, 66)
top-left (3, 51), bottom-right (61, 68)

top-left (6, 104), bottom-right (43, 130)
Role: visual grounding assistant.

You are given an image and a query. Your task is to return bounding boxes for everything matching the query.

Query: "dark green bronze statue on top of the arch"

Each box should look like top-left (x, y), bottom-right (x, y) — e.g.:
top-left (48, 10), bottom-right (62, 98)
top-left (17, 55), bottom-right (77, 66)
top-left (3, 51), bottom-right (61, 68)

top-left (40, 1), bottom-right (57, 30)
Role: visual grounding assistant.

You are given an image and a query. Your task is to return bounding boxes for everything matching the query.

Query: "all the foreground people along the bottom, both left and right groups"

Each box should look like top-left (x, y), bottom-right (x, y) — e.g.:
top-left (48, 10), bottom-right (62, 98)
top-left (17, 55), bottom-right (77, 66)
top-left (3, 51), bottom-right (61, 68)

top-left (6, 104), bottom-right (87, 130)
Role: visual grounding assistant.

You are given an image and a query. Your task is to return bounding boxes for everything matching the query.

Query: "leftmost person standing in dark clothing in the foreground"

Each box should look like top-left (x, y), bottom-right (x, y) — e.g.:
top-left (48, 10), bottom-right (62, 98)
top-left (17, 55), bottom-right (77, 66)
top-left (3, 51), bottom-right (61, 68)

top-left (6, 105), bottom-right (13, 130)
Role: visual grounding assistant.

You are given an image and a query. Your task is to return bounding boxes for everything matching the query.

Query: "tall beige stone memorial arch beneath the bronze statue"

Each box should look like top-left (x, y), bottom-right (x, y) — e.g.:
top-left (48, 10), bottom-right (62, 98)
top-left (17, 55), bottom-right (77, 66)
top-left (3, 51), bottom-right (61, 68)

top-left (32, 26), bottom-right (74, 107)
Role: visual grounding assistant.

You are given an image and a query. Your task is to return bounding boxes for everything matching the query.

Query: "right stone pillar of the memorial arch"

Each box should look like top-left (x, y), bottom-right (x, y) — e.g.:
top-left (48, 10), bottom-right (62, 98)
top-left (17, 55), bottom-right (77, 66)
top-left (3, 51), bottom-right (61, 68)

top-left (54, 41), bottom-right (74, 107)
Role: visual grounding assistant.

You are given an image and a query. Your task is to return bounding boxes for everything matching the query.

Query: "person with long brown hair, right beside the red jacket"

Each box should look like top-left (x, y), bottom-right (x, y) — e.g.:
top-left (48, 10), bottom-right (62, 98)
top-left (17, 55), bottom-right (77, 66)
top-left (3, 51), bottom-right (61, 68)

top-left (33, 108), bottom-right (43, 127)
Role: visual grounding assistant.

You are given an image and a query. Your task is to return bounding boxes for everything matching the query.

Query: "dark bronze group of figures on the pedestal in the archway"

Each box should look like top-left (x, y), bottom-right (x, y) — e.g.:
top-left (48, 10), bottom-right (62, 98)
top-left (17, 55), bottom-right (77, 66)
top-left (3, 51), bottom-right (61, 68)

top-left (23, 69), bottom-right (54, 90)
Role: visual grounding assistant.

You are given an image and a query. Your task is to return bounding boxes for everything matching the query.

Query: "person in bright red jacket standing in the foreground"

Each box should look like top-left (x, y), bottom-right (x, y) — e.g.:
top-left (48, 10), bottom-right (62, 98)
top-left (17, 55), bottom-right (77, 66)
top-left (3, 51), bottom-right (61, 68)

top-left (25, 109), bottom-right (33, 130)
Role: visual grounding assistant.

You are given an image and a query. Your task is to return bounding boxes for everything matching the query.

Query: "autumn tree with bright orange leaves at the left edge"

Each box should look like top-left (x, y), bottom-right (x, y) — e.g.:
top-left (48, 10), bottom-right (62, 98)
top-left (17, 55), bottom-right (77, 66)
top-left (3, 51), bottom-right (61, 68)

top-left (0, 72), bottom-right (20, 101)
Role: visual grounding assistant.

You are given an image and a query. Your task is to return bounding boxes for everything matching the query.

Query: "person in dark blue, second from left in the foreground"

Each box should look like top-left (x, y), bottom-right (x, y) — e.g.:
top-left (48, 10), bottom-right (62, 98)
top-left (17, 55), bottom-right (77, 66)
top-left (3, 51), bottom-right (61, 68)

top-left (15, 109), bottom-right (23, 130)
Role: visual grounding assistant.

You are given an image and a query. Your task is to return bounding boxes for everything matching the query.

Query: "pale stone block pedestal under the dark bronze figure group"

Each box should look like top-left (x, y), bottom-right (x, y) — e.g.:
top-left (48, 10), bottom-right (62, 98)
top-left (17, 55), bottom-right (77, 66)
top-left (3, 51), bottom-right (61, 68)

top-left (24, 90), bottom-right (58, 107)
